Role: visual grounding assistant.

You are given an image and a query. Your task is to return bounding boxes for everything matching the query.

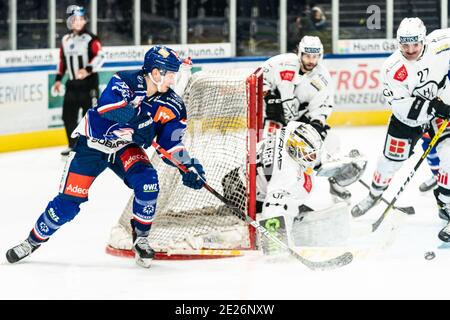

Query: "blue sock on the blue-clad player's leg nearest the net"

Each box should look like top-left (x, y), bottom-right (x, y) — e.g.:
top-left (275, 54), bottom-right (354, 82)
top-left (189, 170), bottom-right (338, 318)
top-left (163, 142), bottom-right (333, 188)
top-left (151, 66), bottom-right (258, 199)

top-left (126, 165), bottom-right (159, 235)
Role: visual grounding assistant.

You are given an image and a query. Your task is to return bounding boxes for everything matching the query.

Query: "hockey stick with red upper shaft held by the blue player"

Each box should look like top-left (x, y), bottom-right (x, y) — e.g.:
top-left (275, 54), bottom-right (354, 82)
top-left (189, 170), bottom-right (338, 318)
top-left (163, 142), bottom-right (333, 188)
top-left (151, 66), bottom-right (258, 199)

top-left (152, 141), bottom-right (353, 270)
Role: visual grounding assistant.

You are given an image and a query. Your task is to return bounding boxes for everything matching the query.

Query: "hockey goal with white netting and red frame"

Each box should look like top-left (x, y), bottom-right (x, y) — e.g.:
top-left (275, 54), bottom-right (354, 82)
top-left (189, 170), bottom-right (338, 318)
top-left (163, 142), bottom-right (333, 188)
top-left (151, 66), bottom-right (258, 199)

top-left (106, 69), bottom-right (262, 259)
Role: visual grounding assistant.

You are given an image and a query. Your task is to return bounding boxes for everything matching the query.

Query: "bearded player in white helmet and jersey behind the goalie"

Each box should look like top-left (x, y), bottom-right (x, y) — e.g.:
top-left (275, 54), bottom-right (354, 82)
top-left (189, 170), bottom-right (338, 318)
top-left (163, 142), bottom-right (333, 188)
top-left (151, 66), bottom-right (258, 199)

top-left (262, 36), bottom-right (351, 200)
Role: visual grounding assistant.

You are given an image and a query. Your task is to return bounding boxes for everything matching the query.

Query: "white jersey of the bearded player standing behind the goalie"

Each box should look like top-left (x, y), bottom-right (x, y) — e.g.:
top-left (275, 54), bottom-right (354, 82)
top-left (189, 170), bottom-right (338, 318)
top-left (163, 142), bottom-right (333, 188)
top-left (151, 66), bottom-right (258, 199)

top-left (262, 53), bottom-right (333, 122)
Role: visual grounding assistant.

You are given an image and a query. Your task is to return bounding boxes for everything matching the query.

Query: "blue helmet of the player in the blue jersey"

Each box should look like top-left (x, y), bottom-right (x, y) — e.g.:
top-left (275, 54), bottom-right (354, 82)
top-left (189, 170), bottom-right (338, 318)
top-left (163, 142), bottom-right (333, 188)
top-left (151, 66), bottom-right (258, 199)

top-left (142, 46), bottom-right (181, 73)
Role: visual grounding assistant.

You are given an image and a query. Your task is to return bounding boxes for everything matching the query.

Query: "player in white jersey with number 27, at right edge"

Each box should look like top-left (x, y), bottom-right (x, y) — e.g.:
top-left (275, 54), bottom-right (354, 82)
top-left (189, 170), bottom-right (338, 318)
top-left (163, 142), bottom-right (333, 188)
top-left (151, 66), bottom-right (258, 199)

top-left (352, 18), bottom-right (450, 242)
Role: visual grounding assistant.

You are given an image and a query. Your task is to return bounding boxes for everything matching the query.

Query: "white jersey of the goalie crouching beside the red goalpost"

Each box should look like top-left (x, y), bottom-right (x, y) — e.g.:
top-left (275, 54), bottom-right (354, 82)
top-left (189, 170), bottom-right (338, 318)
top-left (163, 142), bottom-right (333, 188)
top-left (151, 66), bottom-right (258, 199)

top-left (256, 121), bottom-right (314, 205)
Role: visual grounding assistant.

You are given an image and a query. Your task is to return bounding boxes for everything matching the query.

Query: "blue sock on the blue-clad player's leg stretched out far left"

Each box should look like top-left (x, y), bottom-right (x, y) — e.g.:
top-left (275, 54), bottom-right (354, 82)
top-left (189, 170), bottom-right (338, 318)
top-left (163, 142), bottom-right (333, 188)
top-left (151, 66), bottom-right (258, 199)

top-left (30, 195), bottom-right (80, 243)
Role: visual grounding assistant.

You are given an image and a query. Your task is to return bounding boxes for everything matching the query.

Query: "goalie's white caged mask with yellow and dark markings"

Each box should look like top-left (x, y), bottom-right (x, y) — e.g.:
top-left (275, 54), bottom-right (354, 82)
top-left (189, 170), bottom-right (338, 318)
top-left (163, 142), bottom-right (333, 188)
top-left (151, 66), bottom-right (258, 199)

top-left (286, 122), bottom-right (323, 174)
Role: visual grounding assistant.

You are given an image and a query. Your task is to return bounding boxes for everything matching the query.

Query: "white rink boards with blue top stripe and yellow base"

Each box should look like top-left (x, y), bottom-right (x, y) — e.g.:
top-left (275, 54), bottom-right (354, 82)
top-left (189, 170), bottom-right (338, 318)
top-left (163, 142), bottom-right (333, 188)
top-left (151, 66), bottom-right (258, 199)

top-left (0, 46), bottom-right (390, 152)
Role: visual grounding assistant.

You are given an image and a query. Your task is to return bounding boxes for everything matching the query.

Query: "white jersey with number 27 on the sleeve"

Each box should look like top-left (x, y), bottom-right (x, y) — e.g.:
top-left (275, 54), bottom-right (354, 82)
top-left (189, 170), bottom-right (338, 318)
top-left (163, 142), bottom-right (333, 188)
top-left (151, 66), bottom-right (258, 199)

top-left (382, 29), bottom-right (450, 127)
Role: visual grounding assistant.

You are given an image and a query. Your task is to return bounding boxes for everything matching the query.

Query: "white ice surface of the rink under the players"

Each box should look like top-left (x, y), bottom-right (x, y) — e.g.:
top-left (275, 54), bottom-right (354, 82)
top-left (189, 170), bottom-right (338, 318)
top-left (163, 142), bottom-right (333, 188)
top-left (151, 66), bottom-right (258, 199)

top-left (0, 127), bottom-right (450, 299)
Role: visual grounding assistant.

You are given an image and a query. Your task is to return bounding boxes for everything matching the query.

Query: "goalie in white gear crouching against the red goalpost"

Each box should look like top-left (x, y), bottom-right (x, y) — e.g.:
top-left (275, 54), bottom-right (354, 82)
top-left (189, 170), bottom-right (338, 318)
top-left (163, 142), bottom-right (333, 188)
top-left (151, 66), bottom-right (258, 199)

top-left (222, 121), bottom-right (367, 252)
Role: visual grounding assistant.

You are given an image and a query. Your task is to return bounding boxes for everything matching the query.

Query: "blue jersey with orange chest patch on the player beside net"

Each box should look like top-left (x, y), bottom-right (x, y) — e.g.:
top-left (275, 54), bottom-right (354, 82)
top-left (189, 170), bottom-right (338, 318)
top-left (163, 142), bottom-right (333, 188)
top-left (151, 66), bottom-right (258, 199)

top-left (74, 70), bottom-right (187, 153)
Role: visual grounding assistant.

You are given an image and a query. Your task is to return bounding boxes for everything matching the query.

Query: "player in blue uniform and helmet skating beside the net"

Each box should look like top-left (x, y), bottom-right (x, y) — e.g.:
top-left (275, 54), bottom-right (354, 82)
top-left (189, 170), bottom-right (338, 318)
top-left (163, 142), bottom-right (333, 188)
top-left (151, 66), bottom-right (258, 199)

top-left (6, 46), bottom-right (204, 267)
